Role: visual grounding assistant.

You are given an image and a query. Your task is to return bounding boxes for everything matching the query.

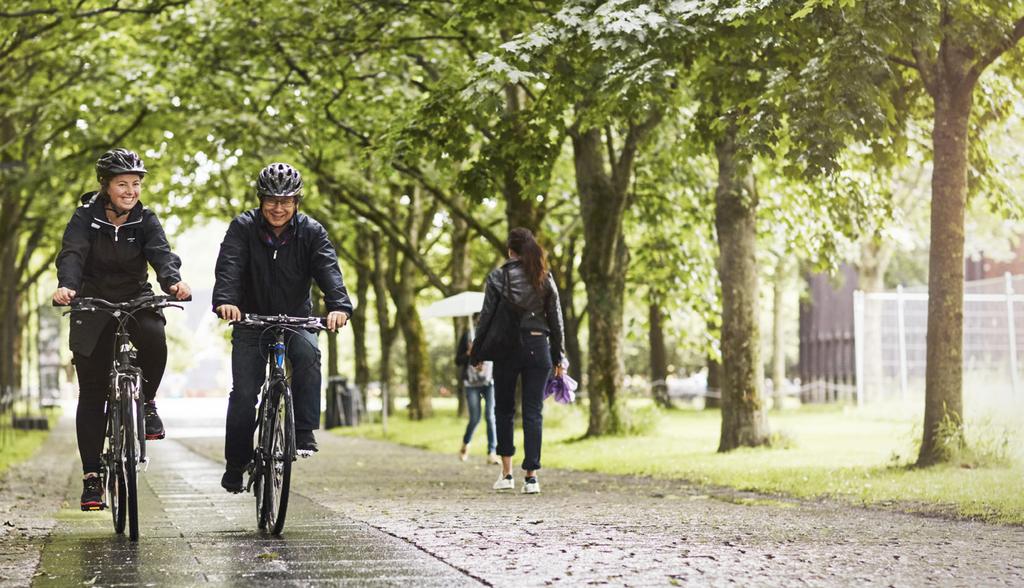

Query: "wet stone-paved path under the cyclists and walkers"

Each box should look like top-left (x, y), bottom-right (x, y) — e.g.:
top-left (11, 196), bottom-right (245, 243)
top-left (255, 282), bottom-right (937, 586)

top-left (0, 405), bottom-right (1024, 587)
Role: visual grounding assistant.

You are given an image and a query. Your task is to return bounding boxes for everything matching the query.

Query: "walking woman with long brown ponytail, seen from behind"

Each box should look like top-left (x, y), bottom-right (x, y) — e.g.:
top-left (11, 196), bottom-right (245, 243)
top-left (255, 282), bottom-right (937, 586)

top-left (471, 228), bottom-right (565, 494)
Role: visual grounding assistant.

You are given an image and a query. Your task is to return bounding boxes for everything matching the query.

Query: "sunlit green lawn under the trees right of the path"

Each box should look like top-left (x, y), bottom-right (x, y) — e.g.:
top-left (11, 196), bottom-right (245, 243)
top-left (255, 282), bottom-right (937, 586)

top-left (334, 398), bottom-right (1024, 524)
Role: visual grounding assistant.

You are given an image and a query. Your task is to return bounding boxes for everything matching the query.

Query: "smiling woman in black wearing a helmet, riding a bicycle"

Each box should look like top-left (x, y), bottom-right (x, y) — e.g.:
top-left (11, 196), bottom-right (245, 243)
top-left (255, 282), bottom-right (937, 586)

top-left (53, 149), bottom-right (191, 510)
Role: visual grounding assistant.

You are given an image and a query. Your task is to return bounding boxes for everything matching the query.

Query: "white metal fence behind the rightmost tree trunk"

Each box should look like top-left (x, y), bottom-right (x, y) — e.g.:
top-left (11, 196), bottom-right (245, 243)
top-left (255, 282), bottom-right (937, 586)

top-left (853, 274), bottom-right (1024, 405)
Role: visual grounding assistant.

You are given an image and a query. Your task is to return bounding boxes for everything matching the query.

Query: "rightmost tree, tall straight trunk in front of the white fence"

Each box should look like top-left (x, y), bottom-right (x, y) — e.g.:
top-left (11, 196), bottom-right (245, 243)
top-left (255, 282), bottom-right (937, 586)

top-left (802, 0), bottom-right (1024, 466)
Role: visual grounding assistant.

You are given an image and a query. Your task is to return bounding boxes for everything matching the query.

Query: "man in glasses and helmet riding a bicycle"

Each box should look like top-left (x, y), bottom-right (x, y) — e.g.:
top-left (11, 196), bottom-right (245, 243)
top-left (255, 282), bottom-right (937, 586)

top-left (213, 163), bottom-right (352, 493)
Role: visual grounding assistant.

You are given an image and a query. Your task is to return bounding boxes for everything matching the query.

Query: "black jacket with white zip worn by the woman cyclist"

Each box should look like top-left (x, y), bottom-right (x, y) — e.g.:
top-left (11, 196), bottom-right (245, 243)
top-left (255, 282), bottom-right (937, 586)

top-left (56, 193), bottom-right (181, 355)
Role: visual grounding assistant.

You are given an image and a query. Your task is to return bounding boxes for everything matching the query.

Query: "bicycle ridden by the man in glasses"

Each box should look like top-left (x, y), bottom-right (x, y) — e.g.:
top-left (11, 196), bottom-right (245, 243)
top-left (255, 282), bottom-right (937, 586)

top-left (231, 314), bottom-right (327, 535)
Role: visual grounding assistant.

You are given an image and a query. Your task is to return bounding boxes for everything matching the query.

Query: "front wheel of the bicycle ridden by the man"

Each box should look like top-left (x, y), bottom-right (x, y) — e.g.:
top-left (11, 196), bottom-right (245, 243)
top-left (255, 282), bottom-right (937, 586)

top-left (263, 383), bottom-right (295, 535)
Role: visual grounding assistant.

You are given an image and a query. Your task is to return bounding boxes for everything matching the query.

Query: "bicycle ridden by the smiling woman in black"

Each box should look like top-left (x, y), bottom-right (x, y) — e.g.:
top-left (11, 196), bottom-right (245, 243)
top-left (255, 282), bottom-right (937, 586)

top-left (54, 295), bottom-right (191, 541)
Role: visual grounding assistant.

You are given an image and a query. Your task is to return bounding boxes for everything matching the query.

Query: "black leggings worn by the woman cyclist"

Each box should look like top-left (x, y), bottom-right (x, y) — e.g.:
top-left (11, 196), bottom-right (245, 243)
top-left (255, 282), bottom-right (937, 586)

top-left (74, 310), bottom-right (167, 473)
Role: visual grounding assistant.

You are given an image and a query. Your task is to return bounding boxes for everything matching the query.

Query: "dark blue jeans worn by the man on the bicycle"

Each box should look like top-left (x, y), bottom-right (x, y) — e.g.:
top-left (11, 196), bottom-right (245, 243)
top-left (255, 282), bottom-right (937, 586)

top-left (224, 327), bottom-right (321, 467)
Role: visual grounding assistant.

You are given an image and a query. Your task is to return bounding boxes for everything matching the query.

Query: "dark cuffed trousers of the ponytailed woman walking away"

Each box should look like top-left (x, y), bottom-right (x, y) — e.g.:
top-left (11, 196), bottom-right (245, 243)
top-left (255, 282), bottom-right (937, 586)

top-left (495, 332), bottom-right (552, 471)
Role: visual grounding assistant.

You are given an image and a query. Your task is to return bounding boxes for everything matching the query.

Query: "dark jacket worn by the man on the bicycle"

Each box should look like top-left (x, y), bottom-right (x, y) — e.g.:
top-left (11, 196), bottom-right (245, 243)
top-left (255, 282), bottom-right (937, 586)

top-left (213, 209), bottom-right (352, 317)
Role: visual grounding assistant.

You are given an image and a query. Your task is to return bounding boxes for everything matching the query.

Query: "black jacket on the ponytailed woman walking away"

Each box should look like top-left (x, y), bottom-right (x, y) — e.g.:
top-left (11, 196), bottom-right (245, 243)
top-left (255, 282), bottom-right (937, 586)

top-left (473, 259), bottom-right (565, 366)
